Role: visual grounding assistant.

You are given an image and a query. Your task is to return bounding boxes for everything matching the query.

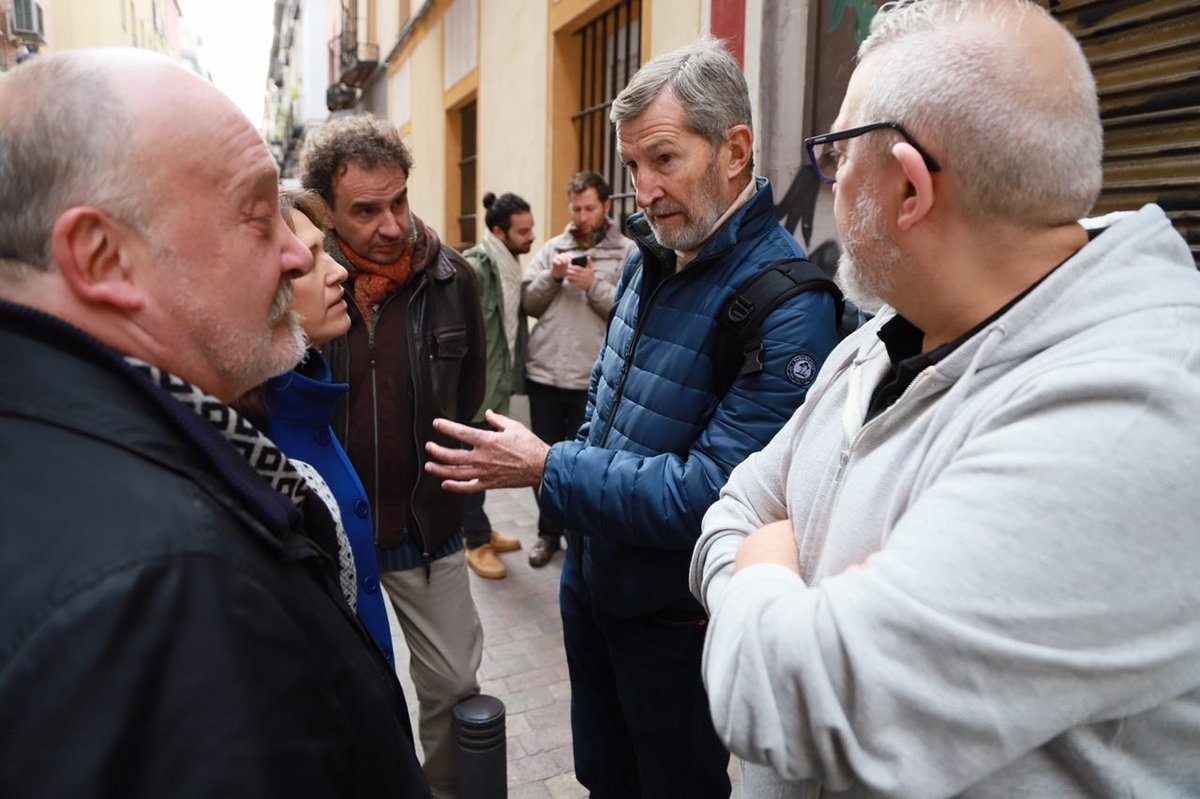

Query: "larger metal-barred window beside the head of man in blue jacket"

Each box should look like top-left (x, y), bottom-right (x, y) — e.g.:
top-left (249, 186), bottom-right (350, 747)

top-left (571, 0), bottom-right (642, 227)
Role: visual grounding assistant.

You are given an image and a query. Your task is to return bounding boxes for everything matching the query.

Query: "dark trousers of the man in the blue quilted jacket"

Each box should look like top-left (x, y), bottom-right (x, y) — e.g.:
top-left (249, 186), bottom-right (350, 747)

top-left (558, 537), bottom-right (730, 799)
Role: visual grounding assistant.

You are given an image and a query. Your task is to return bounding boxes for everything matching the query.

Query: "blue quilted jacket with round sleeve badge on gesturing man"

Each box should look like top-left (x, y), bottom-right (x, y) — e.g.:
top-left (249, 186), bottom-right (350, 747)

top-left (540, 178), bottom-right (838, 615)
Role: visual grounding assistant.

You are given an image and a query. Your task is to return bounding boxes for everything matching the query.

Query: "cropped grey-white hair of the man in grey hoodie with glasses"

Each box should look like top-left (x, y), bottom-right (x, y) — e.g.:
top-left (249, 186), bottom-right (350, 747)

top-left (858, 0), bottom-right (1104, 226)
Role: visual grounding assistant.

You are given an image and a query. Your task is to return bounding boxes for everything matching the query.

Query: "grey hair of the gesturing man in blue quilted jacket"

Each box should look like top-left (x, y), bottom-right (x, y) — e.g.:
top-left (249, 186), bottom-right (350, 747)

top-left (608, 36), bottom-right (754, 169)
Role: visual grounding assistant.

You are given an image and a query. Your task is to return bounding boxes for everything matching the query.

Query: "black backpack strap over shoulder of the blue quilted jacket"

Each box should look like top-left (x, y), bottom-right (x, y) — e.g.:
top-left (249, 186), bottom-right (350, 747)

top-left (721, 258), bottom-right (845, 379)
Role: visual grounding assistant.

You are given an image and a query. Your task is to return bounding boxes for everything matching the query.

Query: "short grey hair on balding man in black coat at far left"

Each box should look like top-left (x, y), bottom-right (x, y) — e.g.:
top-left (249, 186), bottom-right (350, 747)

top-left (0, 52), bottom-right (146, 272)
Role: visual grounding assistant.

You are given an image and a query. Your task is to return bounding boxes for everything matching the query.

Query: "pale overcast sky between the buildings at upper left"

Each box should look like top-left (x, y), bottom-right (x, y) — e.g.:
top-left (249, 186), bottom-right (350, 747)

top-left (179, 0), bottom-right (275, 127)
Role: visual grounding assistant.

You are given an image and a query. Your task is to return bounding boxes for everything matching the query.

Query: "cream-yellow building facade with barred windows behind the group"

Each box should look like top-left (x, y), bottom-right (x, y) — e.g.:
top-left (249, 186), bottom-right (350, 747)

top-left (306, 0), bottom-right (710, 247)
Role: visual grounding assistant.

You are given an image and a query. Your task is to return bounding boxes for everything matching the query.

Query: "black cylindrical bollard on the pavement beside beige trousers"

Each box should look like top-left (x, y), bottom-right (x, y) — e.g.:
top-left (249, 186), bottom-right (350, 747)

top-left (454, 693), bottom-right (509, 799)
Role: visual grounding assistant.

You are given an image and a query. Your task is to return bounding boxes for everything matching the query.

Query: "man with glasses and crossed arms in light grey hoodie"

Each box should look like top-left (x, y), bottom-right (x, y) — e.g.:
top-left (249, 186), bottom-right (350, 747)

top-left (691, 0), bottom-right (1200, 798)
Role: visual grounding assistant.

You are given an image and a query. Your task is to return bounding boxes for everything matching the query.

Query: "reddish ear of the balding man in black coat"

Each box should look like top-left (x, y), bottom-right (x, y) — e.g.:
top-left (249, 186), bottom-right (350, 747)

top-left (50, 206), bottom-right (145, 312)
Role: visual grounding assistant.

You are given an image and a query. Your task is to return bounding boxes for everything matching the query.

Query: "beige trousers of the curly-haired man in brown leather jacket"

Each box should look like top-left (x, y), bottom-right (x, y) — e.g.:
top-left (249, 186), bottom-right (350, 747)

top-left (380, 552), bottom-right (484, 797)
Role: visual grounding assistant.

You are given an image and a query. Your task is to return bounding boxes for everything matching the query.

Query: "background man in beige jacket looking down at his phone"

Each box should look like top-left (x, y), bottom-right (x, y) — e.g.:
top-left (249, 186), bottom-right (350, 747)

top-left (521, 172), bottom-right (635, 569)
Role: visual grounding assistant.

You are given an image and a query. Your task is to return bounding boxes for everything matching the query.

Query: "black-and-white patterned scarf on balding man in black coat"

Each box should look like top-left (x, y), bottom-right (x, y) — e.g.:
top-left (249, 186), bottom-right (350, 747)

top-left (125, 356), bottom-right (358, 609)
